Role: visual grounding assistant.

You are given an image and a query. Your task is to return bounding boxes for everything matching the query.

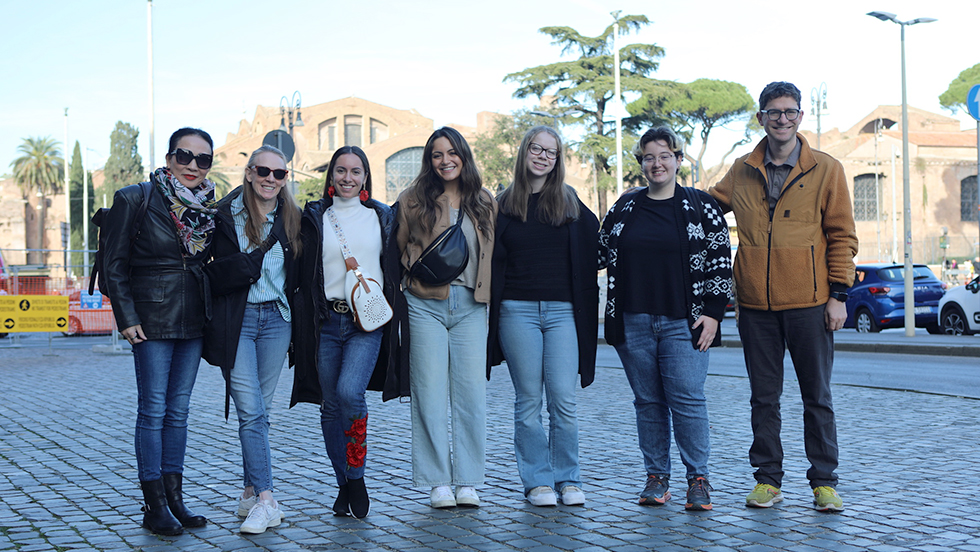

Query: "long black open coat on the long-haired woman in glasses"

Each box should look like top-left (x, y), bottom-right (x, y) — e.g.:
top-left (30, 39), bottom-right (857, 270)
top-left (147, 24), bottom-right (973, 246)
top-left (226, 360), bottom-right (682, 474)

top-left (487, 201), bottom-right (599, 387)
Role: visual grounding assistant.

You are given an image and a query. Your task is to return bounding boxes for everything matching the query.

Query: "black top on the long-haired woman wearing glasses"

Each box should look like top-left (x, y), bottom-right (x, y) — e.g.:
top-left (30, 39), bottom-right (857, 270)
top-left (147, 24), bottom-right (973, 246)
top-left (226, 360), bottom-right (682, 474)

top-left (501, 194), bottom-right (572, 302)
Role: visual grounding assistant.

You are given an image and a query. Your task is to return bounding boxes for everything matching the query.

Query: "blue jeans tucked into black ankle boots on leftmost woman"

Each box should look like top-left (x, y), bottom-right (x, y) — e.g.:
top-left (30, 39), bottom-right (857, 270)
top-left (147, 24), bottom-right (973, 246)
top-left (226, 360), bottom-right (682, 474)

top-left (133, 337), bottom-right (204, 481)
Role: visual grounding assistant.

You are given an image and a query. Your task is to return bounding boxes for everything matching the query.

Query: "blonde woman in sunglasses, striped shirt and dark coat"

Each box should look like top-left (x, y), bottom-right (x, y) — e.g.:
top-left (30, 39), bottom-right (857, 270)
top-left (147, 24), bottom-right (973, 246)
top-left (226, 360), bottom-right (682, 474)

top-left (204, 146), bottom-right (301, 534)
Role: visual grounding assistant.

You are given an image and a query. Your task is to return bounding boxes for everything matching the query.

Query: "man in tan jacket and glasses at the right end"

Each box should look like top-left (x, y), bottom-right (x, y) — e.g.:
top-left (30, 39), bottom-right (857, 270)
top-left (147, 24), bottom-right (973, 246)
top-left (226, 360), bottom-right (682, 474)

top-left (708, 82), bottom-right (858, 511)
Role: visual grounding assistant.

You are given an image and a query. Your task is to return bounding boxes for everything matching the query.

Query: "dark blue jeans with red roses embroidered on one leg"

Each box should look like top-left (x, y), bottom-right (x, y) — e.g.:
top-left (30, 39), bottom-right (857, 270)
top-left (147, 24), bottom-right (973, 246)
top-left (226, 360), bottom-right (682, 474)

top-left (316, 312), bottom-right (384, 485)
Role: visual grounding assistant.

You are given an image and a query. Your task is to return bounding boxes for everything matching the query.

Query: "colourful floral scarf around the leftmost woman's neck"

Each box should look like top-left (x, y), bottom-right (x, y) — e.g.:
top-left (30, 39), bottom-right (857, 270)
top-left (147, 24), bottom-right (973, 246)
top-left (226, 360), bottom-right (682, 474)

top-left (150, 167), bottom-right (218, 257)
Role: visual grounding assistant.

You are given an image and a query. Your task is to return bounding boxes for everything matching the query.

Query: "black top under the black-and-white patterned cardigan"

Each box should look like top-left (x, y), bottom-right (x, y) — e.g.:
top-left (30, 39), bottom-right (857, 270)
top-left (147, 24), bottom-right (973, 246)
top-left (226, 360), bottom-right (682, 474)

top-left (616, 194), bottom-right (687, 318)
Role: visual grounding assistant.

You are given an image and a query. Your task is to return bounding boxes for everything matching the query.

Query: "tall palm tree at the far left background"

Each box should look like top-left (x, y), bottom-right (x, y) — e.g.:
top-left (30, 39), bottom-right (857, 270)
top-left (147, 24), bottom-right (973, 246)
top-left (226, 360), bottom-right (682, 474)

top-left (10, 136), bottom-right (64, 264)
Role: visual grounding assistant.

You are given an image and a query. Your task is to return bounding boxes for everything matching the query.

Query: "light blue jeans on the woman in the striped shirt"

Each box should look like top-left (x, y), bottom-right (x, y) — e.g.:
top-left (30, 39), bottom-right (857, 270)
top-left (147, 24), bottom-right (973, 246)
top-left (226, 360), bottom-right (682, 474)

top-left (230, 301), bottom-right (291, 494)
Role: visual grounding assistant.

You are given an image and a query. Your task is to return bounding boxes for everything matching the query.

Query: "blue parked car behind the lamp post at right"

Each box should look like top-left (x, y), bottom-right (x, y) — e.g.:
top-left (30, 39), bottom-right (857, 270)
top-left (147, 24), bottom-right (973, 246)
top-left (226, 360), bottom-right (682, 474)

top-left (844, 263), bottom-right (946, 333)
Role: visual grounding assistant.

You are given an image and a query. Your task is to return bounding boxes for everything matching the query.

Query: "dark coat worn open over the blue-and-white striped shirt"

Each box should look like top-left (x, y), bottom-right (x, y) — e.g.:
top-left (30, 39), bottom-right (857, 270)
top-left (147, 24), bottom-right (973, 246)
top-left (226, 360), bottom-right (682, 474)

top-left (203, 186), bottom-right (299, 381)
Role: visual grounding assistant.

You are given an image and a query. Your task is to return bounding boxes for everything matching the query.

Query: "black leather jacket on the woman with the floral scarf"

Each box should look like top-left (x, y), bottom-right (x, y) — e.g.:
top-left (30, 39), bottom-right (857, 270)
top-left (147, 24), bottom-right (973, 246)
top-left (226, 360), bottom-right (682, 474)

top-left (103, 185), bottom-right (210, 339)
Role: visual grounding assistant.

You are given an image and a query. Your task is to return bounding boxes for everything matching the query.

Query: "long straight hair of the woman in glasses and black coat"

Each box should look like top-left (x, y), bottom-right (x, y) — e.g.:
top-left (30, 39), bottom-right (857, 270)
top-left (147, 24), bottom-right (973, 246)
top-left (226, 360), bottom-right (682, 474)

top-left (497, 125), bottom-right (579, 226)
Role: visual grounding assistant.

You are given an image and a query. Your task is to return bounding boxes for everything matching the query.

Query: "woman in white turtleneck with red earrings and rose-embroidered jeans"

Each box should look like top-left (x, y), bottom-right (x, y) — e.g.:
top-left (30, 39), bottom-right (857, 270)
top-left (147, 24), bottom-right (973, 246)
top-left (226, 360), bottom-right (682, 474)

top-left (290, 146), bottom-right (398, 518)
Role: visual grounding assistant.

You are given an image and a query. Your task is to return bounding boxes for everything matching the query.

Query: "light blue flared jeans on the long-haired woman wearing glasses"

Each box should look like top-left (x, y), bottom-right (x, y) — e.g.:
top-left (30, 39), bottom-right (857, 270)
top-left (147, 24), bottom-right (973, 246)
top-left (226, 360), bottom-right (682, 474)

top-left (500, 300), bottom-right (582, 494)
